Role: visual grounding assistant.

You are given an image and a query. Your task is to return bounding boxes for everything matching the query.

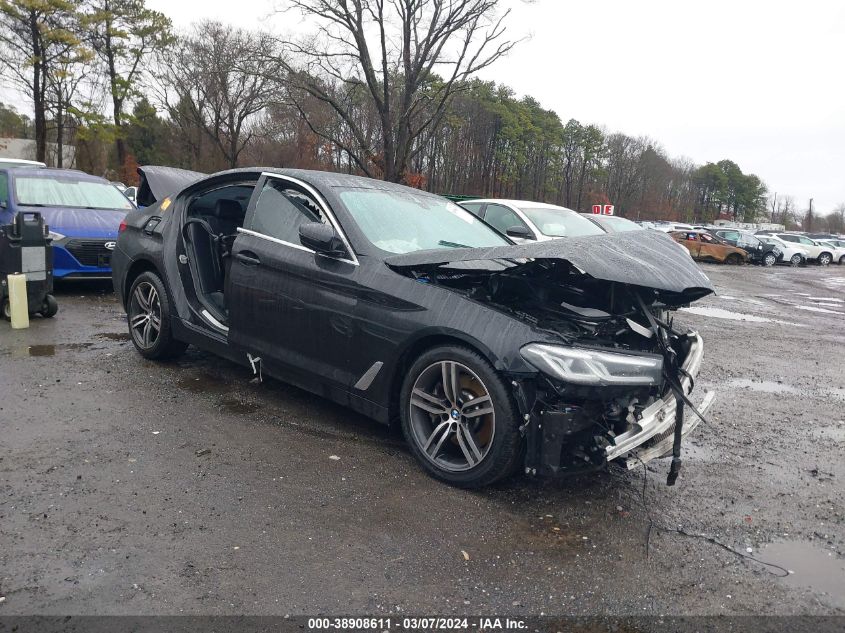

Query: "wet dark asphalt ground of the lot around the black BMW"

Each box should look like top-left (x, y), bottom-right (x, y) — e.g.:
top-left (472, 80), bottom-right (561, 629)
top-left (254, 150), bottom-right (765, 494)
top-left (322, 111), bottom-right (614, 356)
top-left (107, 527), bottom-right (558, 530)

top-left (0, 266), bottom-right (845, 615)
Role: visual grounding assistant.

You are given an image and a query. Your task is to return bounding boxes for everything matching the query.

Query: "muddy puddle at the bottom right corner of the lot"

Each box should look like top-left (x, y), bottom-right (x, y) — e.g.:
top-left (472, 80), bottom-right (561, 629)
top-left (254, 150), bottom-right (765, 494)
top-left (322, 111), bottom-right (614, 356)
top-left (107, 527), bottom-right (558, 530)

top-left (756, 541), bottom-right (845, 608)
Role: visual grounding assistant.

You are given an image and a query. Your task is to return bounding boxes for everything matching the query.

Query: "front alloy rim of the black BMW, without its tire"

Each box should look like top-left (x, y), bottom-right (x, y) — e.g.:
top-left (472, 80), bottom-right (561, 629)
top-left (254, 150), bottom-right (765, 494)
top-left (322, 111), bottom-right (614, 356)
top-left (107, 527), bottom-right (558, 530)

top-left (408, 360), bottom-right (496, 472)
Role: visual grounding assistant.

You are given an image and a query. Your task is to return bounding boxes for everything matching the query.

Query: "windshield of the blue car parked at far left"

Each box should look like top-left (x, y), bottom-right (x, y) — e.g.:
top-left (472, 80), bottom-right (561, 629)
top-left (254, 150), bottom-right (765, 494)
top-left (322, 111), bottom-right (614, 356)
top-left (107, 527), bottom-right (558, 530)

top-left (15, 175), bottom-right (134, 211)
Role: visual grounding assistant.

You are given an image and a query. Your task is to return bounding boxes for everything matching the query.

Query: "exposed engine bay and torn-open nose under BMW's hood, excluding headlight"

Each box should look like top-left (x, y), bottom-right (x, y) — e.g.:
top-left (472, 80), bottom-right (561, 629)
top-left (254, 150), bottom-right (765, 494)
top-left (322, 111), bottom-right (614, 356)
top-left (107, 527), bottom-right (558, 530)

top-left (398, 259), bottom-right (703, 485)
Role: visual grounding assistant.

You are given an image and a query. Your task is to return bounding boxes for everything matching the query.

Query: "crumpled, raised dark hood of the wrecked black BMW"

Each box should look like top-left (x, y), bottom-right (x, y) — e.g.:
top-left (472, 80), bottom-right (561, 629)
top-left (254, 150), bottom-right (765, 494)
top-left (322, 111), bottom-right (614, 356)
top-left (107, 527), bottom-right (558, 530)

top-left (385, 230), bottom-right (714, 301)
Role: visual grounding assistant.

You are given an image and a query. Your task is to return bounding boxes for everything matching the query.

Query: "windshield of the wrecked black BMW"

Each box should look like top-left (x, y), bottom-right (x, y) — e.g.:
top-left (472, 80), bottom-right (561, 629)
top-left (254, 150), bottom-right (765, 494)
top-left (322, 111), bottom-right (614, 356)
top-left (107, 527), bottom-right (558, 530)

top-left (340, 189), bottom-right (511, 253)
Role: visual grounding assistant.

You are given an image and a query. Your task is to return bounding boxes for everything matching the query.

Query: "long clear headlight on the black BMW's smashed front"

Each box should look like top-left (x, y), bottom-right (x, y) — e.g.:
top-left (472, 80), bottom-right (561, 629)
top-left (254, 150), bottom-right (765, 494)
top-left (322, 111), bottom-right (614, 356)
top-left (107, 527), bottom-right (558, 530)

top-left (519, 343), bottom-right (663, 387)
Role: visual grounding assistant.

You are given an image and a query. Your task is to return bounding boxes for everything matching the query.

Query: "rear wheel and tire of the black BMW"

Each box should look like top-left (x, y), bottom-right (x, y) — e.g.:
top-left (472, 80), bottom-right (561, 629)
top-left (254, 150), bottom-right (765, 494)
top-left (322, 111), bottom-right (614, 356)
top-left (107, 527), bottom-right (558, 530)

top-left (126, 271), bottom-right (188, 360)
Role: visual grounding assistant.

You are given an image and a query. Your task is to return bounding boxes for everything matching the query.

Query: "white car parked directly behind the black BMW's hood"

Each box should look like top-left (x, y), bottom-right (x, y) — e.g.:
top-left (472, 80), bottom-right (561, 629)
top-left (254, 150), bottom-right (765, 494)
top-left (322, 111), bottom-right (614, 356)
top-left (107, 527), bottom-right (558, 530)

top-left (458, 199), bottom-right (604, 243)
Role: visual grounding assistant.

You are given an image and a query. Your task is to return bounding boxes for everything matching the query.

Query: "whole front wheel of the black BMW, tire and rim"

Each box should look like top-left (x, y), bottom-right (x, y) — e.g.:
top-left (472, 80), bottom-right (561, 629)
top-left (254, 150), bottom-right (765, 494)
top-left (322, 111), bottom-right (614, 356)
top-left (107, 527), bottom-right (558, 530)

top-left (399, 345), bottom-right (522, 488)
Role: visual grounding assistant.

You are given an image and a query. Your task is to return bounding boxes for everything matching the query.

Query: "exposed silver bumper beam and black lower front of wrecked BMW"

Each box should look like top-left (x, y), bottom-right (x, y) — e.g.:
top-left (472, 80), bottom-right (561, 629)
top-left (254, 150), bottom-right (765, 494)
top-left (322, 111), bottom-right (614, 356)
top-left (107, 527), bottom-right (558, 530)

top-left (516, 332), bottom-right (716, 475)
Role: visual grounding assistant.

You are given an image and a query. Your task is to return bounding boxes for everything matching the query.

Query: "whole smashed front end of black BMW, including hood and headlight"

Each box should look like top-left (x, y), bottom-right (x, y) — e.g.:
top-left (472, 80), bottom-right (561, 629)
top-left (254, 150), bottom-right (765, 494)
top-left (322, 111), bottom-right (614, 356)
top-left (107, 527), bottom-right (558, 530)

top-left (389, 236), bottom-right (714, 485)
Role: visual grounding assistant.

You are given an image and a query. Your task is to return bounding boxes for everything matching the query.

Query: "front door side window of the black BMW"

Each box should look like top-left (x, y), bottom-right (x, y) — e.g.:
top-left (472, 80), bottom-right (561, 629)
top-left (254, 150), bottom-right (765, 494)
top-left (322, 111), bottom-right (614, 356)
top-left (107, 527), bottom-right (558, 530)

top-left (246, 179), bottom-right (324, 245)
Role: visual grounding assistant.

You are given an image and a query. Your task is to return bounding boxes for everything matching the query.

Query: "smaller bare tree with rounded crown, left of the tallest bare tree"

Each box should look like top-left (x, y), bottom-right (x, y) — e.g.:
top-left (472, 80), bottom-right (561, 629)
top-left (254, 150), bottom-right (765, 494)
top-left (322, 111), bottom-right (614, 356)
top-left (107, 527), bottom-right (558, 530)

top-left (157, 21), bottom-right (281, 167)
